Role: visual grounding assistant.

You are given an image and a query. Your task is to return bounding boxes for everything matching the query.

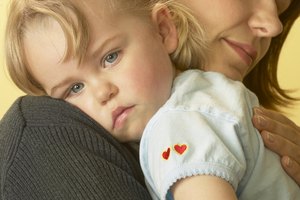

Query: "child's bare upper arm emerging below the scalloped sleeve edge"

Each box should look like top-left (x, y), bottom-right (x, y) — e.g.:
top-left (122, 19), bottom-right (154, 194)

top-left (172, 175), bottom-right (237, 200)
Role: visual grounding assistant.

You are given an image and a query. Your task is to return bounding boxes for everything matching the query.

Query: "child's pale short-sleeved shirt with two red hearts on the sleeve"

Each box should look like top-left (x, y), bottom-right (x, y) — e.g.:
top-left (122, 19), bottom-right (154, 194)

top-left (140, 70), bottom-right (300, 200)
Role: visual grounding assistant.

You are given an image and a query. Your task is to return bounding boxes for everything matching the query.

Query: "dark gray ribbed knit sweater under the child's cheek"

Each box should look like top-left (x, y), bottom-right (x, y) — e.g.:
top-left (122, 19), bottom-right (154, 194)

top-left (0, 96), bottom-right (150, 200)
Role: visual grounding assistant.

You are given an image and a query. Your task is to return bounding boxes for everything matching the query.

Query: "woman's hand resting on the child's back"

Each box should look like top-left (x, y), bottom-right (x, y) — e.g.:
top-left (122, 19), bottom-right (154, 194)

top-left (252, 107), bottom-right (300, 186)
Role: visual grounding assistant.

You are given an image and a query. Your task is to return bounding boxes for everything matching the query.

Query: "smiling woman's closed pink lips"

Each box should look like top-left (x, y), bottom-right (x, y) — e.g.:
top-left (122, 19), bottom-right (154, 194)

top-left (224, 39), bottom-right (257, 66)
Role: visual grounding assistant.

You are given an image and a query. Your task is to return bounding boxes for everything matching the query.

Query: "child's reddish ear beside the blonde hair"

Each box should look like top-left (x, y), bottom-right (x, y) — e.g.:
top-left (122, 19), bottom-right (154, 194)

top-left (152, 4), bottom-right (178, 54)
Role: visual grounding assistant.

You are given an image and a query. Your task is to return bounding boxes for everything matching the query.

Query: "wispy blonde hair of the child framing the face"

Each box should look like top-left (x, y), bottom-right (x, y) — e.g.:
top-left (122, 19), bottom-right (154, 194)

top-left (5, 0), bottom-right (205, 95)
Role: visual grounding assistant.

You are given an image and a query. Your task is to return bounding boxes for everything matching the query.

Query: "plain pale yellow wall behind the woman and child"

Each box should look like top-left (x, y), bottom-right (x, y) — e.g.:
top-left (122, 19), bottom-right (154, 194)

top-left (0, 0), bottom-right (300, 125)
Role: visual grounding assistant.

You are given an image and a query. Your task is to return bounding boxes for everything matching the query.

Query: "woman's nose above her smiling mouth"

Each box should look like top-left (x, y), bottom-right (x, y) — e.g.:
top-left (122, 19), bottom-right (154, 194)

top-left (248, 0), bottom-right (283, 37)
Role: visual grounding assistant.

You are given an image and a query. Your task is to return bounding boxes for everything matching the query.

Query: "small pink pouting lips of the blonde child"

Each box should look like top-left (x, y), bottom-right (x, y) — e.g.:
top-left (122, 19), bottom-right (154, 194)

top-left (112, 106), bottom-right (133, 129)
